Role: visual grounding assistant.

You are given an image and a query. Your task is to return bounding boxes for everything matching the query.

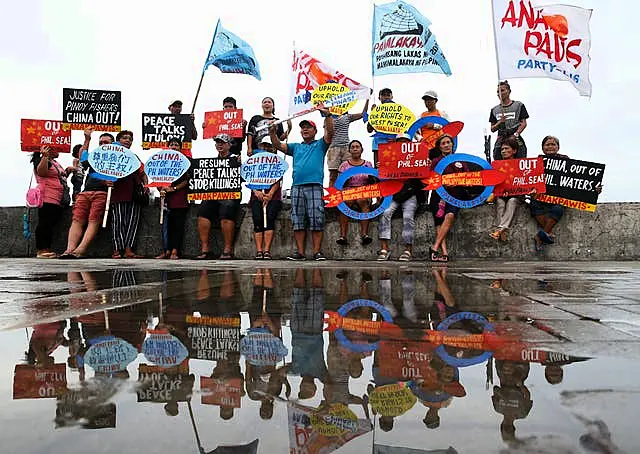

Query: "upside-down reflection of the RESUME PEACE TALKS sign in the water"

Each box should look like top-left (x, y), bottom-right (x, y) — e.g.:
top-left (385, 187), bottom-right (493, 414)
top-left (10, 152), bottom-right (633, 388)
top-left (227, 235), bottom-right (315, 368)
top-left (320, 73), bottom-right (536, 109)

top-left (186, 315), bottom-right (240, 361)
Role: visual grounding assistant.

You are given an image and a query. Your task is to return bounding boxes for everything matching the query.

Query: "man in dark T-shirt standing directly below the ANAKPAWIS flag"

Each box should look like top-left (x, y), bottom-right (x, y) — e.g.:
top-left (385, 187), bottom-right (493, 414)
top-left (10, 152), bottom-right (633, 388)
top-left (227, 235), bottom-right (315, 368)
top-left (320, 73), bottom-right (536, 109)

top-left (489, 80), bottom-right (529, 160)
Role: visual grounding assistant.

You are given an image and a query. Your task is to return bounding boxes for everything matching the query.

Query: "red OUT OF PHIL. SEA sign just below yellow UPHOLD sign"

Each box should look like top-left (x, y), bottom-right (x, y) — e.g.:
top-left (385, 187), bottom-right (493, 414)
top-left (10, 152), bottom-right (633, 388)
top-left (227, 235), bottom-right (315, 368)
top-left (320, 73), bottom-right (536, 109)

top-left (378, 142), bottom-right (431, 180)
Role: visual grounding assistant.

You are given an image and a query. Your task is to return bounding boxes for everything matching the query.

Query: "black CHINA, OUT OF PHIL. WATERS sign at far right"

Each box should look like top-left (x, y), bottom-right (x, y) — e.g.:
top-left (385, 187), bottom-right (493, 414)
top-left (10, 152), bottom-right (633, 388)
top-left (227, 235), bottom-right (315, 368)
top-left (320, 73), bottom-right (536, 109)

top-left (535, 156), bottom-right (605, 212)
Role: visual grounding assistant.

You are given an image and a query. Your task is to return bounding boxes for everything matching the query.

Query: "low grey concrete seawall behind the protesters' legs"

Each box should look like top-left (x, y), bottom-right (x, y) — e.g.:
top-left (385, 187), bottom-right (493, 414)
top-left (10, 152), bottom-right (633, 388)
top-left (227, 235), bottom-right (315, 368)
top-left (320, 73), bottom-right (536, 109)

top-left (0, 202), bottom-right (640, 260)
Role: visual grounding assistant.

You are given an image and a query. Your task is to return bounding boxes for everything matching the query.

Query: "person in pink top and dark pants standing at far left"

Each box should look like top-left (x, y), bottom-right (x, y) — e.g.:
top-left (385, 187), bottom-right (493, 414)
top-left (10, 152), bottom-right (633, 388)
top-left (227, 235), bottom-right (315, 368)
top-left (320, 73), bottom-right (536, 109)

top-left (31, 145), bottom-right (69, 259)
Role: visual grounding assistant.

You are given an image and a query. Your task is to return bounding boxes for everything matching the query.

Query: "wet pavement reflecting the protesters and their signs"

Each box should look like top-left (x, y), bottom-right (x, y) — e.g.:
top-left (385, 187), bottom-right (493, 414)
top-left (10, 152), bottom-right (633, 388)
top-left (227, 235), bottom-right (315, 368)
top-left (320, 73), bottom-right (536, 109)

top-left (0, 259), bottom-right (640, 454)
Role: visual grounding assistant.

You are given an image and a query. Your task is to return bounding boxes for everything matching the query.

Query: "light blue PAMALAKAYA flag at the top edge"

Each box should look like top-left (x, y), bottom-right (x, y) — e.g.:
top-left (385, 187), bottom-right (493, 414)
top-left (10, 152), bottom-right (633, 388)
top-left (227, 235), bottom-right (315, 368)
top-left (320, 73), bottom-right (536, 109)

top-left (371, 0), bottom-right (451, 76)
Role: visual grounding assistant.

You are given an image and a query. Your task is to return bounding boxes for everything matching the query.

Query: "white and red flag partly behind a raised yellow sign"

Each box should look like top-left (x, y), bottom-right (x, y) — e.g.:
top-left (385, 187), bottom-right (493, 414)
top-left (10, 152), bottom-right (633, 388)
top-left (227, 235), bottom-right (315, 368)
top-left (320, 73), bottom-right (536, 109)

top-left (289, 49), bottom-right (371, 115)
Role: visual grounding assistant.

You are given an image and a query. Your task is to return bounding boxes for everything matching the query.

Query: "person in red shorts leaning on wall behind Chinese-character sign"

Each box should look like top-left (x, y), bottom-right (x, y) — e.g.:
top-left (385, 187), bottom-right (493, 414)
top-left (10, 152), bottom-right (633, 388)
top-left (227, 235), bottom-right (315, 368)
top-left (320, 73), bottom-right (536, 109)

top-left (59, 128), bottom-right (114, 259)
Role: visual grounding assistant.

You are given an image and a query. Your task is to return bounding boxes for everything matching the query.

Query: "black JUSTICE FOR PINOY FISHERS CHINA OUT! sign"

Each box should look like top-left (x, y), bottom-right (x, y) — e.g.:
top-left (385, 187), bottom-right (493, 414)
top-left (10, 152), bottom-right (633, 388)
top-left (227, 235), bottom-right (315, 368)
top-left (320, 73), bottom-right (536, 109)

top-left (62, 88), bottom-right (122, 132)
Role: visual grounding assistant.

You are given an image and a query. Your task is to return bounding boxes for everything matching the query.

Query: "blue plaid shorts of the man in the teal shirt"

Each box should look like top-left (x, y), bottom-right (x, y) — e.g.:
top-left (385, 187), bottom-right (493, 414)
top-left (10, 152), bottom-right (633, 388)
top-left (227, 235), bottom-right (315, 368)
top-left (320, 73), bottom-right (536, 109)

top-left (291, 183), bottom-right (324, 232)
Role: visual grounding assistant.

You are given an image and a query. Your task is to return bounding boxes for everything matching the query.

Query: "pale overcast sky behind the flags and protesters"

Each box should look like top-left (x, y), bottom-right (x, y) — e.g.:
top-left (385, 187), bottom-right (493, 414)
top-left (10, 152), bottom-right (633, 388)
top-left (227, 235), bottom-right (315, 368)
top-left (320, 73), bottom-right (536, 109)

top-left (0, 0), bottom-right (640, 205)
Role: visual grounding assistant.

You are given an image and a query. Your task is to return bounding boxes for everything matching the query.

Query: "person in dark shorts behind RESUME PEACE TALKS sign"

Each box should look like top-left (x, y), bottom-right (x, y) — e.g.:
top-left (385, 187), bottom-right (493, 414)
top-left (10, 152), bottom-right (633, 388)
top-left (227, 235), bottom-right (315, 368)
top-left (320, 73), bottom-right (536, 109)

top-left (196, 134), bottom-right (240, 260)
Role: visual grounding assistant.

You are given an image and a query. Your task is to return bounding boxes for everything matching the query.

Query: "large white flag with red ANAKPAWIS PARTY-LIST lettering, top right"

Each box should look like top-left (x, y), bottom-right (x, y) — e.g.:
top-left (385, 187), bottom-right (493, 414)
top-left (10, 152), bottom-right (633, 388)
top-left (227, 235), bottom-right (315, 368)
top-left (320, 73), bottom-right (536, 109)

top-left (492, 0), bottom-right (592, 96)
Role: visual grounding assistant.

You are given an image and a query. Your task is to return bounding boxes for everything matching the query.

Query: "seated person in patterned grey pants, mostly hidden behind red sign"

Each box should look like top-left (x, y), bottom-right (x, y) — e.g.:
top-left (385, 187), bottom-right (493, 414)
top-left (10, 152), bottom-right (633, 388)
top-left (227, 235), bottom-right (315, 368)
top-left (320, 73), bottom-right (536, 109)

top-left (378, 134), bottom-right (424, 262)
